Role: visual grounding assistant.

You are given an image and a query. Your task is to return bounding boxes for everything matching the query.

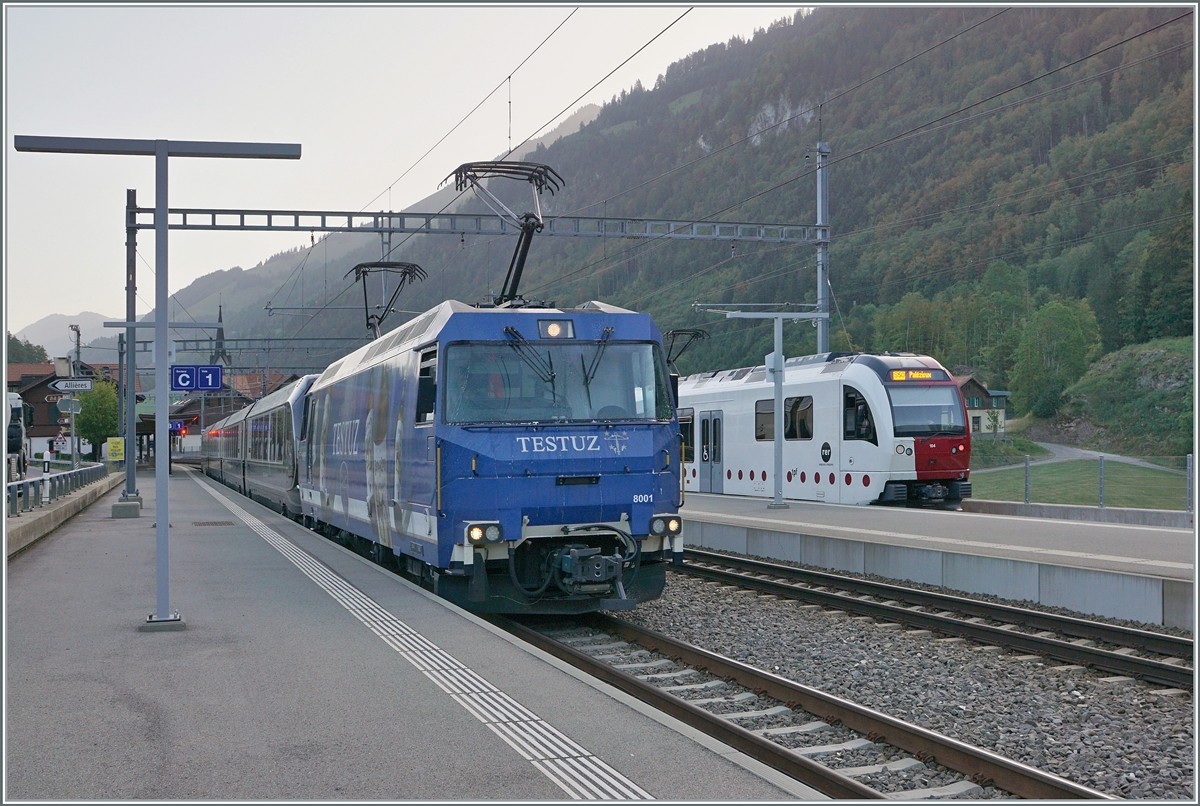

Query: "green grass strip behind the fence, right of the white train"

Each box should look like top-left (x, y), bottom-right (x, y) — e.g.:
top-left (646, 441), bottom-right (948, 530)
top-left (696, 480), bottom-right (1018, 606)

top-left (971, 459), bottom-right (1188, 510)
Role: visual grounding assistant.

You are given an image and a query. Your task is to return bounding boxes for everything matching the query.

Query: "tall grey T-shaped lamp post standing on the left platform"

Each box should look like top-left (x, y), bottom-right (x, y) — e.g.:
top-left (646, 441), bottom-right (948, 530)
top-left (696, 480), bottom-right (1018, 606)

top-left (14, 134), bottom-right (300, 631)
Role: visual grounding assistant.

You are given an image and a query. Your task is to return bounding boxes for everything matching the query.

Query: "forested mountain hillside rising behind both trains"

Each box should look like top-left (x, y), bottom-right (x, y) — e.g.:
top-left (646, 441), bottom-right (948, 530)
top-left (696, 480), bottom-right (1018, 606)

top-left (140, 6), bottom-right (1194, 426)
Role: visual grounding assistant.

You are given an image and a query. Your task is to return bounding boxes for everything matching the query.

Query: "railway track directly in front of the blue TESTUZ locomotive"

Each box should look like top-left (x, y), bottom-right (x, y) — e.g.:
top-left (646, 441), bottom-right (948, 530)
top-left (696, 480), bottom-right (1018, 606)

top-left (496, 615), bottom-right (1111, 800)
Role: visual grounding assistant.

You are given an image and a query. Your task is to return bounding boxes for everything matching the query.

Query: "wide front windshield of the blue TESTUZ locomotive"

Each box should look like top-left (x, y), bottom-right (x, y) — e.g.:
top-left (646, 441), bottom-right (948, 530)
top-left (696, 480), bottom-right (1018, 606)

top-left (443, 341), bottom-right (672, 423)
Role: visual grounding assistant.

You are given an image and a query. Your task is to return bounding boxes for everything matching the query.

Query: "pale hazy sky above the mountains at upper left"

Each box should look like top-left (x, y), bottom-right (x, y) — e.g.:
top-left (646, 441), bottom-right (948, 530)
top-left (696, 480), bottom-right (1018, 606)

top-left (4, 4), bottom-right (798, 341)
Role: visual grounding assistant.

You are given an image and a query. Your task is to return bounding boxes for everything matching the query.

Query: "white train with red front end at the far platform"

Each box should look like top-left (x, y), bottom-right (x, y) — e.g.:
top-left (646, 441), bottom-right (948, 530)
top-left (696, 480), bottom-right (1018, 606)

top-left (679, 353), bottom-right (971, 509)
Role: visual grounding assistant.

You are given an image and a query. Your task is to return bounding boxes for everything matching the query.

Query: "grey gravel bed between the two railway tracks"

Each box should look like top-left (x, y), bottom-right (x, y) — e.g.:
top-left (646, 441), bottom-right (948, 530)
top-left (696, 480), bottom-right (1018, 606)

top-left (623, 575), bottom-right (1195, 800)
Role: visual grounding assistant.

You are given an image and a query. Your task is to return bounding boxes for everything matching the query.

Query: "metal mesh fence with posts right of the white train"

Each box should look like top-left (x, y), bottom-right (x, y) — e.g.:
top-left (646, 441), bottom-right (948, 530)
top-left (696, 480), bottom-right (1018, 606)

top-left (971, 453), bottom-right (1195, 512)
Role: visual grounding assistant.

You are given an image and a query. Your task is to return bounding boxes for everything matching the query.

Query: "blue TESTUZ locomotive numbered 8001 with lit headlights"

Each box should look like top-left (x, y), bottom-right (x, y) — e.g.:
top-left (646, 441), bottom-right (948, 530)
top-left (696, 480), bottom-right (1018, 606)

top-left (300, 301), bottom-right (683, 613)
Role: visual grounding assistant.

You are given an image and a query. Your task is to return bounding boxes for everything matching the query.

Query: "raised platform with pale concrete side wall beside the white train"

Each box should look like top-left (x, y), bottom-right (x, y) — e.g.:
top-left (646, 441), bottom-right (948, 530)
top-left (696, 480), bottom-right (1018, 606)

top-left (680, 493), bottom-right (1196, 630)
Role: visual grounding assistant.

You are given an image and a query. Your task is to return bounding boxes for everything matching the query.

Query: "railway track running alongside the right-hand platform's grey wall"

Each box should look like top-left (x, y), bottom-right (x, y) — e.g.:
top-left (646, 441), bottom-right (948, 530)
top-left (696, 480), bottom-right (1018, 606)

top-left (672, 548), bottom-right (1195, 690)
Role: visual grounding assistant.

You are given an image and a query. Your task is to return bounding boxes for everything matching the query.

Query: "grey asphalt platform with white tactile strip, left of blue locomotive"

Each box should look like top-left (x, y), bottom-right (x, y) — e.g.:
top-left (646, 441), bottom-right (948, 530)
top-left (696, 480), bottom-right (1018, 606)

top-left (4, 471), bottom-right (824, 801)
